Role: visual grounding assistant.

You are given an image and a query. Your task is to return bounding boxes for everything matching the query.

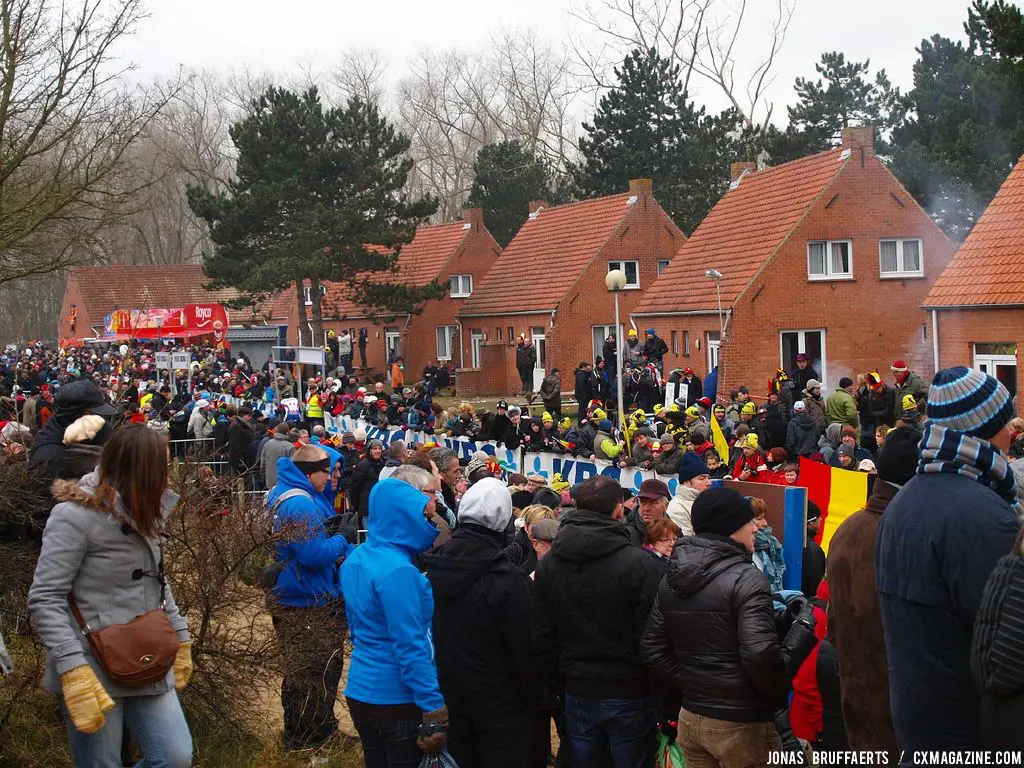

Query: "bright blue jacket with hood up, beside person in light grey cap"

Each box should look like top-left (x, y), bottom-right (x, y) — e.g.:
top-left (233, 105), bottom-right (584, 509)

top-left (341, 478), bottom-right (444, 712)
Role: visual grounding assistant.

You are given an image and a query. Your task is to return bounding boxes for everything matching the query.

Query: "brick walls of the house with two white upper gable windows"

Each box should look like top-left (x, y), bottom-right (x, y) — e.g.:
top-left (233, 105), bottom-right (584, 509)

top-left (645, 153), bottom-right (954, 395)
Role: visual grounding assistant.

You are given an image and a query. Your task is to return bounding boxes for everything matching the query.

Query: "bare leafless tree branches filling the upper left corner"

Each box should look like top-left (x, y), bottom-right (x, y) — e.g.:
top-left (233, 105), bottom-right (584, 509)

top-left (0, 0), bottom-right (179, 285)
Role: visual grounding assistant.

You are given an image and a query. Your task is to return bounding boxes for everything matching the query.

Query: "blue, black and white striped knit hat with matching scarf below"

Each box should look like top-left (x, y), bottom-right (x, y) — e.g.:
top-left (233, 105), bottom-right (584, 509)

top-left (928, 366), bottom-right (1014, 440)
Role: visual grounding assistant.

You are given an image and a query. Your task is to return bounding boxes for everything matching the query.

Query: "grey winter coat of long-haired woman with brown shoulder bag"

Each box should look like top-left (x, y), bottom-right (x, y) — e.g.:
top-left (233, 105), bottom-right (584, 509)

top-left (29, 472), bottom-right (189, 698)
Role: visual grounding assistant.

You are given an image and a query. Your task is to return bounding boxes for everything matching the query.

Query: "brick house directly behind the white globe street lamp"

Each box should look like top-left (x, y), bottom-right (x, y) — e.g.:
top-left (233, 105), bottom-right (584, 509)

top-left (458, 179), bottom-right (686, 393)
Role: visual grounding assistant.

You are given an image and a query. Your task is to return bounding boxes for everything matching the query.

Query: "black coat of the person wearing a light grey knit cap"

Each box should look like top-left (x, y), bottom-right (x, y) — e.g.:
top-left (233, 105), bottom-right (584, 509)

top-left (421, 523), bottom-right (538, 716)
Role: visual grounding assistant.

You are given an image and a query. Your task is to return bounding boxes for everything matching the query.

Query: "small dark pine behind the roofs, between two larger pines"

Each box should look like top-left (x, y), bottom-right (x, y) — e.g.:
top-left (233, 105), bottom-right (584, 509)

top-left (468, 140), bottom-right (554, 248)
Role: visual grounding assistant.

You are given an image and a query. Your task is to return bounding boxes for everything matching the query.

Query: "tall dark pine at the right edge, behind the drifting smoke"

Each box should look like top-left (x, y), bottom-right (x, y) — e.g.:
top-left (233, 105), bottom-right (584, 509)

top-left (893, 0), bottom-right (1024, 241)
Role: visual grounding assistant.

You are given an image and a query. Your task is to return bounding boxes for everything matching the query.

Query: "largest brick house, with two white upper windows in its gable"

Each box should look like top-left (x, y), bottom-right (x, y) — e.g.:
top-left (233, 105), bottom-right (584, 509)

top-left (633, 126), bottom-right (954, 396)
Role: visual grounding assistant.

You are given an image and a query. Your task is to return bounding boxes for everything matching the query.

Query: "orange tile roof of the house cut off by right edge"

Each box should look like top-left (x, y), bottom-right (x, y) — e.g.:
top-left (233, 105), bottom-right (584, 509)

top-left (923, 158), bottom-right (1024, 307)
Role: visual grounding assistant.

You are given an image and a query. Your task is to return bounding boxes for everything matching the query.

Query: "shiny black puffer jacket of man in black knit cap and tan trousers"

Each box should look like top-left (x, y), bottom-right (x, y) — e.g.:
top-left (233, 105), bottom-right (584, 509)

top-left (640, 534), bottom-right (817, 723)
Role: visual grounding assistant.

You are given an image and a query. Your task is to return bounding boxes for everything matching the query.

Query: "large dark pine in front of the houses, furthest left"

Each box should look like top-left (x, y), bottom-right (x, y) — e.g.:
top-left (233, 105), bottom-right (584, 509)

top-left (188, 88), bottom-right (442, 344)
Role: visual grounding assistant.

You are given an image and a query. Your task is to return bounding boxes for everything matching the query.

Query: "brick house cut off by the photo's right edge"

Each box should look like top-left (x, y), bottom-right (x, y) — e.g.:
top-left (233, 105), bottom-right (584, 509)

top-left (923, 154), bottom-right (1024, 405)
